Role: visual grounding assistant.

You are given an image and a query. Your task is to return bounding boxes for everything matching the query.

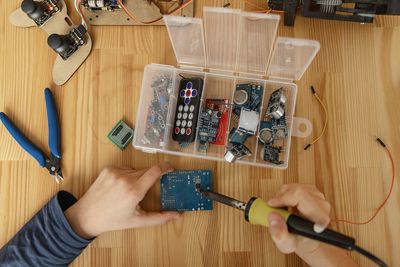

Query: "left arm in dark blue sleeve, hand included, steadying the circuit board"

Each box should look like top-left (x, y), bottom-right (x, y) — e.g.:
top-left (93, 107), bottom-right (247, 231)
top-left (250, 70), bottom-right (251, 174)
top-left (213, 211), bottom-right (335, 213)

top-left (0, 164), bottom-right (180, 267)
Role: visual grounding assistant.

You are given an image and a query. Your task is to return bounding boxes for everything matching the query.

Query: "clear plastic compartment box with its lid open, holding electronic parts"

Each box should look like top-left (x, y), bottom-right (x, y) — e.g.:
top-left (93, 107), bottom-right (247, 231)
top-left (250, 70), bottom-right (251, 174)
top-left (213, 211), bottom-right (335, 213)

top-left (133, 7), bottom-right (320, 169)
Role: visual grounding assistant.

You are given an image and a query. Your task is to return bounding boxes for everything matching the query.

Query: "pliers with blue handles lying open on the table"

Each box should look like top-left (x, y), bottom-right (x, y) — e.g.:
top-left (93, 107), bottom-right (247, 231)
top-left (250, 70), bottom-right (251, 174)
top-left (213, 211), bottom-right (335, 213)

top-left (0, 88), bottom-right (64, 183)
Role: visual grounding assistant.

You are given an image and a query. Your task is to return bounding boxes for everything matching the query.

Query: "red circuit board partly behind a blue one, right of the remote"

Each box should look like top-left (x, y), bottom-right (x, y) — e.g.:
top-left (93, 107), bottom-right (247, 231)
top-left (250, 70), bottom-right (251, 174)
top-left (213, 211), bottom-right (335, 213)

top-left (206, 99), bottom-right (231, 145)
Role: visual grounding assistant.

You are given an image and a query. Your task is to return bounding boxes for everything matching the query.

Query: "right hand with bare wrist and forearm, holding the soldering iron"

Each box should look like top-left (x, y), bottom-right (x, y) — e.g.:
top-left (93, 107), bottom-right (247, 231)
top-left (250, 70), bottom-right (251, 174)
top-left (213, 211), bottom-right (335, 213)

top-left (268, 184), bottom-right (357, 267)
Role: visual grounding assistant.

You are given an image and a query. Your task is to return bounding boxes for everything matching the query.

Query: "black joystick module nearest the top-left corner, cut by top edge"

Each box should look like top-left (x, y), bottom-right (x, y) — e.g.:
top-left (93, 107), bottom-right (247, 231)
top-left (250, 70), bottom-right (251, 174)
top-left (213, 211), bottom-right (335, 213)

top-left (21, 0), bottom-right (60, 26)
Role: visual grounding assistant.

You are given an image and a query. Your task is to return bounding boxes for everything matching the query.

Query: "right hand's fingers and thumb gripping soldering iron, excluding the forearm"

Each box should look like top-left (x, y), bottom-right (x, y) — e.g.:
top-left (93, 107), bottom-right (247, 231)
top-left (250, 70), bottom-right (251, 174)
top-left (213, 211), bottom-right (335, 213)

top-left (268, 184), bottom-right (331, 255)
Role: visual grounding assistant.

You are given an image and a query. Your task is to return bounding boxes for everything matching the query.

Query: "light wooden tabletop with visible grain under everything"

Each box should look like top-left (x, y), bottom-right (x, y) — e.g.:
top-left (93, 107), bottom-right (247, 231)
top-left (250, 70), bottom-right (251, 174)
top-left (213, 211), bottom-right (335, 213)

top-left (0, 0), bottom-right (400, 266)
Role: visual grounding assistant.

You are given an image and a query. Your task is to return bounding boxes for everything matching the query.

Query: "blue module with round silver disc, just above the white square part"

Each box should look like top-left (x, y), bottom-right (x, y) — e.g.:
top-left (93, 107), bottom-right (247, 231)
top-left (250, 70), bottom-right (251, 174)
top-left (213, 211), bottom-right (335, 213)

top-left (233, 83), bottom-right (264, 120)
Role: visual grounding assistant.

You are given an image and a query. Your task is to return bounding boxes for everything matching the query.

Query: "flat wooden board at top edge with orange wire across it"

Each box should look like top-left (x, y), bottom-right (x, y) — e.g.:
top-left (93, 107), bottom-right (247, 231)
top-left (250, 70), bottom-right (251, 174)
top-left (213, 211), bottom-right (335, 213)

top-left (82, 0), bottom-right (194, 25)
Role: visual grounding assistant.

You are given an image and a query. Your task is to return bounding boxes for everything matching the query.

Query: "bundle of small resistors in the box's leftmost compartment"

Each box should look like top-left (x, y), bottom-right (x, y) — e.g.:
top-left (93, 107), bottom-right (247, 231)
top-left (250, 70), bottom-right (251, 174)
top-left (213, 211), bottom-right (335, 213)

top-left (141, 75), bottom-right (172, 146)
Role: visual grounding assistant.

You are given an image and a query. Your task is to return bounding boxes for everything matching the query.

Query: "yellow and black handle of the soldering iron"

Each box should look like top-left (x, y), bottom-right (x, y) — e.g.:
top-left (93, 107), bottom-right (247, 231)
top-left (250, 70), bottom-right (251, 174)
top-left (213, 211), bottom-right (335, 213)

top-left (244, 197), bottom-right (355, 250)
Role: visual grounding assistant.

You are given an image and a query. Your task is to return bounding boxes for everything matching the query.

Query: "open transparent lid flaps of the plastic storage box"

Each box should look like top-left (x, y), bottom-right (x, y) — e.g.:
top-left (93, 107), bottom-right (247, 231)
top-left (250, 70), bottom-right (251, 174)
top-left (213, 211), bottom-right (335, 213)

top-left (164, 7), bottom-right (320, 81)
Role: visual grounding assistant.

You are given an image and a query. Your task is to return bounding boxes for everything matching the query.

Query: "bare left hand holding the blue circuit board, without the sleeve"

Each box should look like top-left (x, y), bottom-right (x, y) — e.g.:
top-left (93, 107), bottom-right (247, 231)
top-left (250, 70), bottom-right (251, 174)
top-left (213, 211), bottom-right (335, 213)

top-left (65, 163), bottom-right (180, 239)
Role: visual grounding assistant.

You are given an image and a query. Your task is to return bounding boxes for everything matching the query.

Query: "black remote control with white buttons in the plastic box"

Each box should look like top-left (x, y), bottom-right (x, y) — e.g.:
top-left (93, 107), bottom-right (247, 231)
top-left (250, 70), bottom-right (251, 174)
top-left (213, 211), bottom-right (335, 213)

top-left (172, 78), bottom-right (203, 143)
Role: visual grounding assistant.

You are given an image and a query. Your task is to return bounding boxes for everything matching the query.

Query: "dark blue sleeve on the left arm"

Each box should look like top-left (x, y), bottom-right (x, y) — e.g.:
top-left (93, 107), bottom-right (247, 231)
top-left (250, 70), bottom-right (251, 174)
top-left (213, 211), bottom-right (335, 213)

top-left (0, 191), bottom-right (92, 267)
